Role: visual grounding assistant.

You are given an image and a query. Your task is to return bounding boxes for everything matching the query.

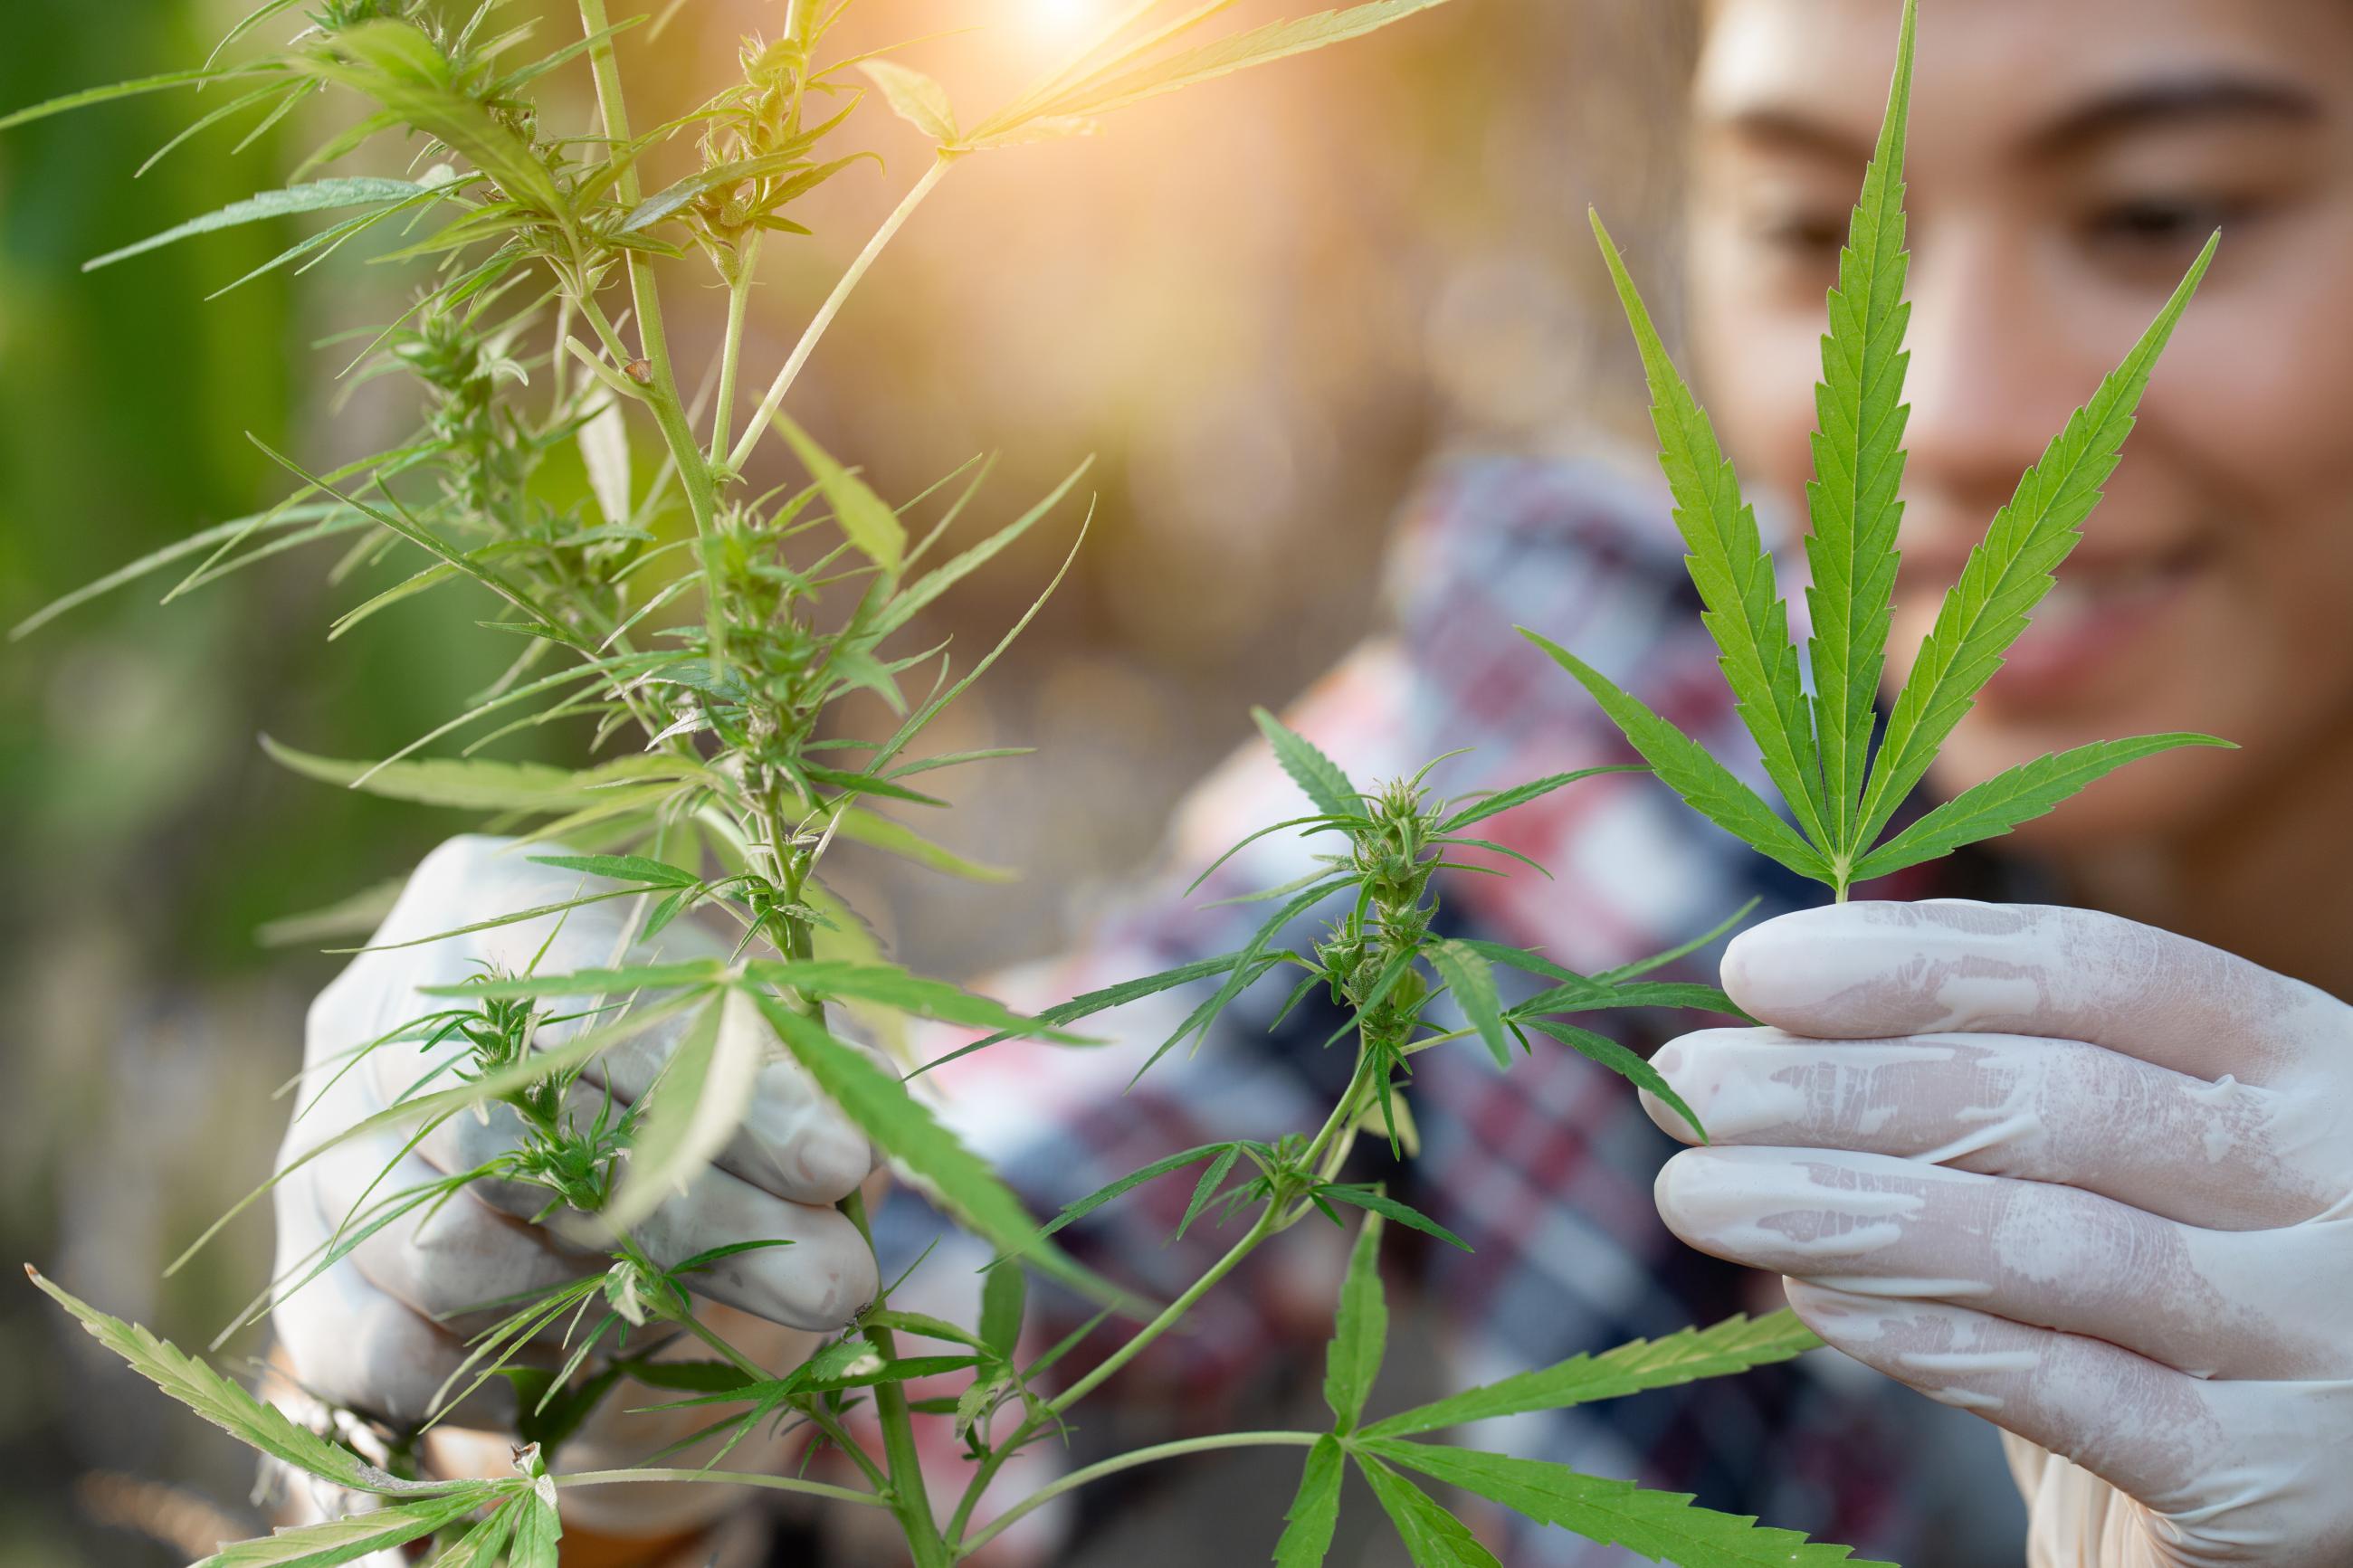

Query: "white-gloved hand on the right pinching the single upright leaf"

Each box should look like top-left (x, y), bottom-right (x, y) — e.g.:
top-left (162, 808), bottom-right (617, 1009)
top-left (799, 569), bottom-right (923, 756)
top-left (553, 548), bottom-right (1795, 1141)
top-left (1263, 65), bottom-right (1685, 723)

top-left (1650, 903), bottom-right (2353, 1568)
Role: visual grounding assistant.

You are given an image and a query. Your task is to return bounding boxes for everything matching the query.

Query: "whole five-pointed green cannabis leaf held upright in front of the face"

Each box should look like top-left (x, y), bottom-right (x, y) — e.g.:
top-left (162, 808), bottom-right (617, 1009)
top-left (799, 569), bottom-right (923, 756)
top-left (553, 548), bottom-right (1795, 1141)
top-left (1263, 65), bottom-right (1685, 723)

top-left (1520, 0), bottom-right (2228, 900)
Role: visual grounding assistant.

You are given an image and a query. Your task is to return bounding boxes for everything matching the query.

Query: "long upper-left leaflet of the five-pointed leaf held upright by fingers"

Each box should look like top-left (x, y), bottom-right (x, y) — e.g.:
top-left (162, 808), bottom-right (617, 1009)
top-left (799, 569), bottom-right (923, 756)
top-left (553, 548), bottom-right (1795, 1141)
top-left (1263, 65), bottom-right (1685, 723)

top-left (1588, 214), bottom-right (1824, 853)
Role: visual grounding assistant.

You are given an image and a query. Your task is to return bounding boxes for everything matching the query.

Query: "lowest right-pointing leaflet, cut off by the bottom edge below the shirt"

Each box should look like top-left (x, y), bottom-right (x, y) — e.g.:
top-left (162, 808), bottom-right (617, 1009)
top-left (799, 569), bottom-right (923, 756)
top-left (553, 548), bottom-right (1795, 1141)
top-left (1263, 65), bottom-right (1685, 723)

top-left (1358, 1439), bottom-right (1891, 1568)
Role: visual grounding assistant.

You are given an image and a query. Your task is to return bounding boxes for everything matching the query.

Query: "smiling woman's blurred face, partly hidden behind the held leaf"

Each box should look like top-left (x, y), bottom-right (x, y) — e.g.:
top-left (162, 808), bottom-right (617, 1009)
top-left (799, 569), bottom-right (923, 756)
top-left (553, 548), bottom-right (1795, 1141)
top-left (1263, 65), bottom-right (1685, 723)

top-left (1691, 0), bottom-right (2353, 853)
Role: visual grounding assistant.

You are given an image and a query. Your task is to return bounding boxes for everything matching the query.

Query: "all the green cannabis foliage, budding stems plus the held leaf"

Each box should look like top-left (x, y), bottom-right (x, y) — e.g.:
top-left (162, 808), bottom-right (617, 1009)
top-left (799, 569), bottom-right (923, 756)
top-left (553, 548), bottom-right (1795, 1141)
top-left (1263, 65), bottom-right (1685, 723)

top-left (14, 0), bottom-right (2205, 1568)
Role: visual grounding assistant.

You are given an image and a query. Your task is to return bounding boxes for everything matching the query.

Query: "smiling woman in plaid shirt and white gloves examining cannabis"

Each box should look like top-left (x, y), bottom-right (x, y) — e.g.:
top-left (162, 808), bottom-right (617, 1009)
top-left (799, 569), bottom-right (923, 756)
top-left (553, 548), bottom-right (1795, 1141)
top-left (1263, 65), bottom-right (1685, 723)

top-left (280, 0), bottom-right (2353, 1568)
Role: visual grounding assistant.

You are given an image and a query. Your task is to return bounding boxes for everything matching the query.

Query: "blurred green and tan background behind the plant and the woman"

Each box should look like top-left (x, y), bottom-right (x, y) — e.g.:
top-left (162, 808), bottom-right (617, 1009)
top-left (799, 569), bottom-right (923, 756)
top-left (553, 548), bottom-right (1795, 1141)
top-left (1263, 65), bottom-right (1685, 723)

top-left (0, 0), bottom-right (1690, 1568)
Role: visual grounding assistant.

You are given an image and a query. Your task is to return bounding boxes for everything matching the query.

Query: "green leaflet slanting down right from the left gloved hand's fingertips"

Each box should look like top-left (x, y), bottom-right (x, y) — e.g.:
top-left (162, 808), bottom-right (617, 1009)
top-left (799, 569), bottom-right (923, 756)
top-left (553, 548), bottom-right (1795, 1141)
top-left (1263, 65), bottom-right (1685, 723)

top-left (750, 990), bottom-right (1132, 1307)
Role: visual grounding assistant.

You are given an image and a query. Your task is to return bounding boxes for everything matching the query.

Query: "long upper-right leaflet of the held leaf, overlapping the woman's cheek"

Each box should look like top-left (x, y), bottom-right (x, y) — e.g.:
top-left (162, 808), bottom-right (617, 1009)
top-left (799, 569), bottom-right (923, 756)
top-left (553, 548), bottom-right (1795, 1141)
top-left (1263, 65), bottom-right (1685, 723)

top-left (1854, 233), bottom-right (2221, 860)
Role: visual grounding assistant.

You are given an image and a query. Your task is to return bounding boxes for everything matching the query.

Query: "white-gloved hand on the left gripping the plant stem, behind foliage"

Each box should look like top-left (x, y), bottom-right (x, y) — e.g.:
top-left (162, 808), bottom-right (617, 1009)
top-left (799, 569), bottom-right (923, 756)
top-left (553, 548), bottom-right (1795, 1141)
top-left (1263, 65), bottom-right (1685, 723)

top-left (273, 837), bottom-right (875, 1535)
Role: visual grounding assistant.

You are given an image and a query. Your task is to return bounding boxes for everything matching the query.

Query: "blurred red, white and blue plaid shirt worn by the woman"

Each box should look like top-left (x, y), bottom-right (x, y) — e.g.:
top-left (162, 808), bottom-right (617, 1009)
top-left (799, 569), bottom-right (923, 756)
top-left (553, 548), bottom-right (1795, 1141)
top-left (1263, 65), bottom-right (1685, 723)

top-left (856, 459), bottom-right (2019, 1568)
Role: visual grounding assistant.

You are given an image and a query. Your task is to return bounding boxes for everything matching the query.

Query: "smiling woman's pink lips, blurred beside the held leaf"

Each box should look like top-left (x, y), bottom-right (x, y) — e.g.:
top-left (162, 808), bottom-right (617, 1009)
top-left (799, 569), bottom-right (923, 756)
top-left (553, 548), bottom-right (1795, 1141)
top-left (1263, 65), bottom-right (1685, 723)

top-left (1906, 546), bottom-right (2209, 705)
